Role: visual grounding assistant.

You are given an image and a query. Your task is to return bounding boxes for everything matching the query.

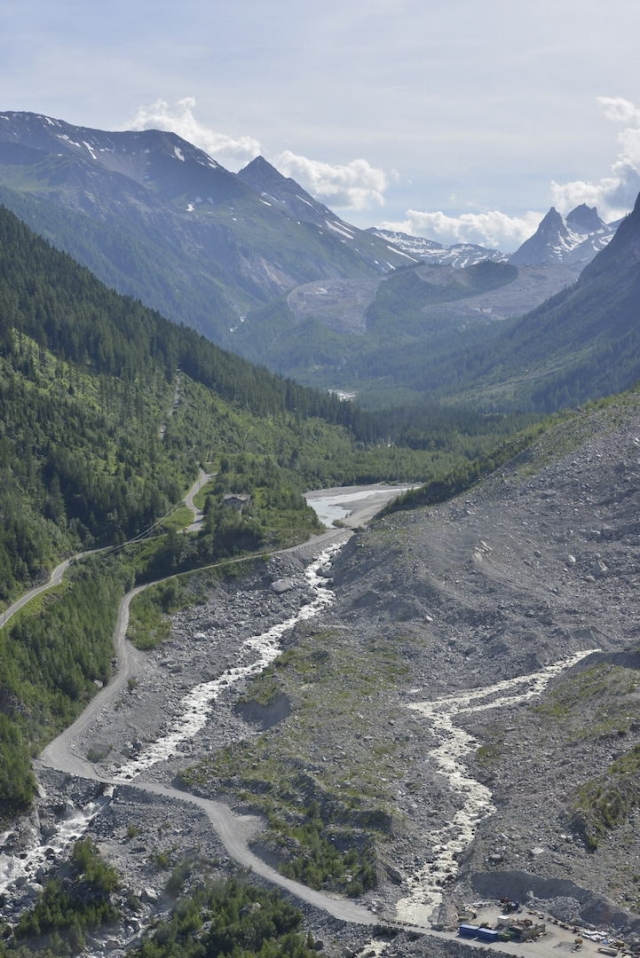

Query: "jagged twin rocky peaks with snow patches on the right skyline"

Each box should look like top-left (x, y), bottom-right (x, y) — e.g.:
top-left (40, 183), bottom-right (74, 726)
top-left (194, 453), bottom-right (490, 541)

top-left (509, 203), bottom-right (615, 266)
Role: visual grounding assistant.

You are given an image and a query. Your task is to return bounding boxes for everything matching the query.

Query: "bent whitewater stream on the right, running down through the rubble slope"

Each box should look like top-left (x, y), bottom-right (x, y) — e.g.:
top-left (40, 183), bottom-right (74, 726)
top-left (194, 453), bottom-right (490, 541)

top-left (396, 649), bottom-right (598, 925)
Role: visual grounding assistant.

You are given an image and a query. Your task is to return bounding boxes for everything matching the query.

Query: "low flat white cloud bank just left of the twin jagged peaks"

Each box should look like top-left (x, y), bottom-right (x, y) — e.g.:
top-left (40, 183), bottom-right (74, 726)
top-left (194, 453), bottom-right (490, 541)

top-left (379, 210), bottom-right (542, 252)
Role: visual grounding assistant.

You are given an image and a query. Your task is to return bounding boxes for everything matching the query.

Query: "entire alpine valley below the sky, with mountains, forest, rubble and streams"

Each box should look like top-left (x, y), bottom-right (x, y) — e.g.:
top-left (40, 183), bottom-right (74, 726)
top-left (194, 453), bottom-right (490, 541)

top-left (0, 112), bottom-right (640, 958)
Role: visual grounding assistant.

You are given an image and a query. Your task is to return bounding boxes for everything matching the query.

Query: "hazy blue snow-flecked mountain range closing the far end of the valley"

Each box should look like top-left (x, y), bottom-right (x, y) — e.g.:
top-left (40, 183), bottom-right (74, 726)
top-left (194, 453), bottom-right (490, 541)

top-left (0, 112), bottom-right (624, 406)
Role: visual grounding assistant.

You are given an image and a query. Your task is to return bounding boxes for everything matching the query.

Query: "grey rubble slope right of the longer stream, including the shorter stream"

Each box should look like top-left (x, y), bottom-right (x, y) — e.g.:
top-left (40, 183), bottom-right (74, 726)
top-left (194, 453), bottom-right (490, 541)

top-left (191, 396), bottom-right (640, 931)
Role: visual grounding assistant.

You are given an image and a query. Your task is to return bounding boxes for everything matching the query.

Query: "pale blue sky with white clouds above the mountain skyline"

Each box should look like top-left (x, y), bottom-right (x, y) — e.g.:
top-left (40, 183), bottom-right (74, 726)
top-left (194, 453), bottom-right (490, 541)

top-left (0, 0), bottom-right (640, 250)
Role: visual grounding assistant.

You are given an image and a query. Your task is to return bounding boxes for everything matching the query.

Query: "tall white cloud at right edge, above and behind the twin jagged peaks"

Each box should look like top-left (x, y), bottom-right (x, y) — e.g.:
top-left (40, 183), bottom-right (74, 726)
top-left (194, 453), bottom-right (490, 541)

top-left (551, 96), bottom-right (640, 221)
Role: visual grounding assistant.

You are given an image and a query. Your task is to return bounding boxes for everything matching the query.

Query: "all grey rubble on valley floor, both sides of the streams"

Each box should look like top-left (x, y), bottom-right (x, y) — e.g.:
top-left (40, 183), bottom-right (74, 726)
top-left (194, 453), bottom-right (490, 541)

top-left (5, 395), bottom-right (640, 956)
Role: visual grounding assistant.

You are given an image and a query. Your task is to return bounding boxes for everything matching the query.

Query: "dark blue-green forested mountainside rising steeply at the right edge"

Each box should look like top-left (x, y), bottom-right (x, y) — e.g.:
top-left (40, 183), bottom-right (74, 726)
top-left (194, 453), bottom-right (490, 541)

top-left (439, 191), bottom-right (640, 411)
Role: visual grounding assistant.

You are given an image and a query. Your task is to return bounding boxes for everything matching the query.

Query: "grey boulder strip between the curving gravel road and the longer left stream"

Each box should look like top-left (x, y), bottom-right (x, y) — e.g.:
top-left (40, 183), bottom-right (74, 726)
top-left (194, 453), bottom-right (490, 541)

top-left (79, 555), bottom-right (311, 781)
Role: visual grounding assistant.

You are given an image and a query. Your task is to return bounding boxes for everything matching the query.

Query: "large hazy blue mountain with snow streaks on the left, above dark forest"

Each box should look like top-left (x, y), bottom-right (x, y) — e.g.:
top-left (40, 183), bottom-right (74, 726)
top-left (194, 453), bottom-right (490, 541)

top-left (0, 113), bottom-right (410, 345)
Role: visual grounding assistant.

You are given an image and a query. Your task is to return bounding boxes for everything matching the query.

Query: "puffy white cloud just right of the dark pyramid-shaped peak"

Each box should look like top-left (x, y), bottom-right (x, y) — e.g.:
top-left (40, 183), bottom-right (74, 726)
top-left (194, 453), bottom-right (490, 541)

top-left (274, 150), bottom-right (388, 210)
